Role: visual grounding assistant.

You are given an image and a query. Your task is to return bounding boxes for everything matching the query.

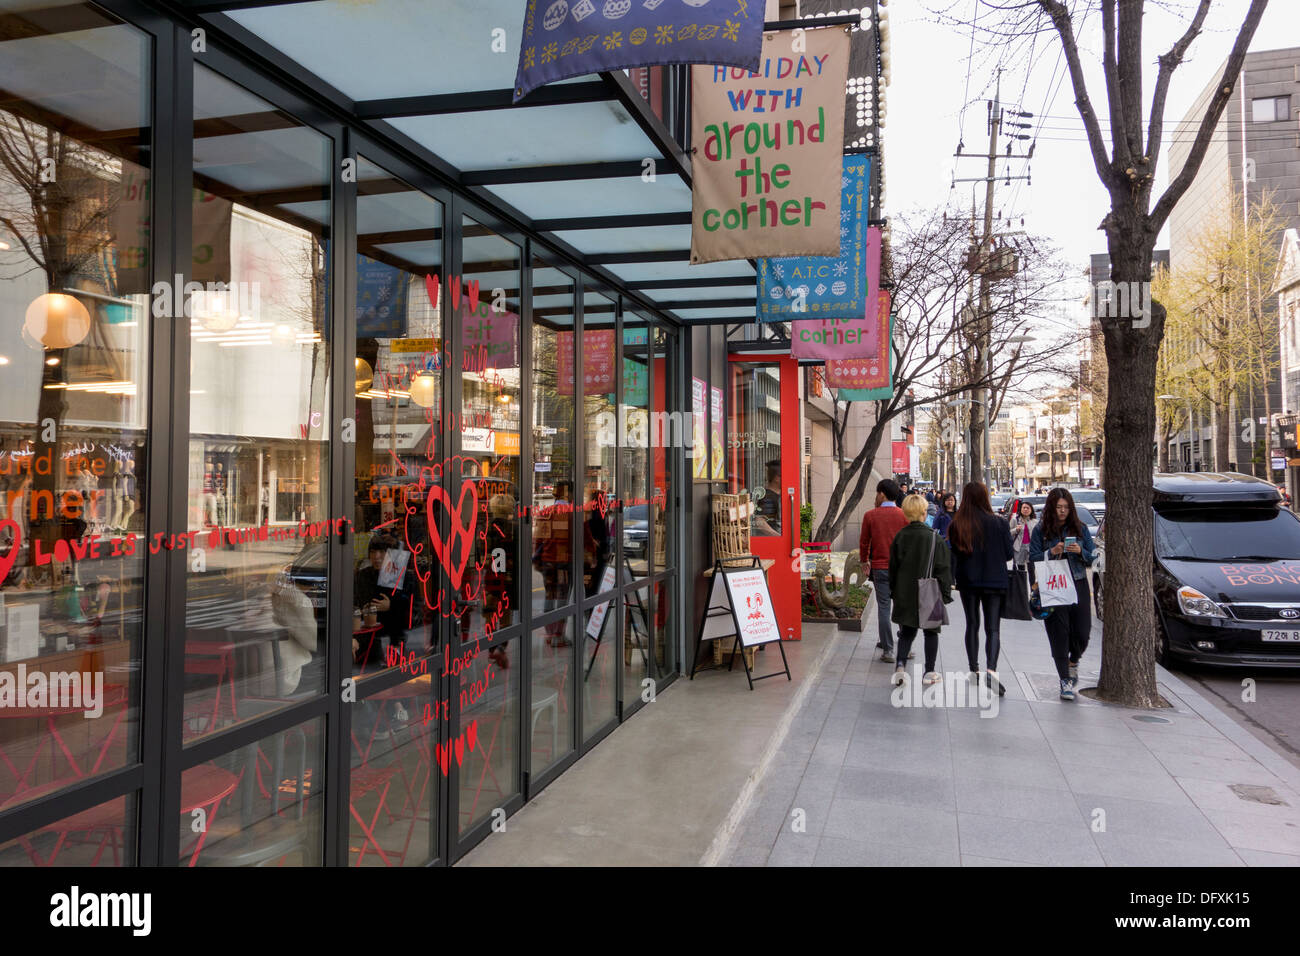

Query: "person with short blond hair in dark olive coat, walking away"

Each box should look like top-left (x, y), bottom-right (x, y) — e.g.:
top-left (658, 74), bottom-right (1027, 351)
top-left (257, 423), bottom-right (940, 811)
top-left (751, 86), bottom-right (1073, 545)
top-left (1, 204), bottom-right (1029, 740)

top-left (889, 494), bottom-right (953, 684)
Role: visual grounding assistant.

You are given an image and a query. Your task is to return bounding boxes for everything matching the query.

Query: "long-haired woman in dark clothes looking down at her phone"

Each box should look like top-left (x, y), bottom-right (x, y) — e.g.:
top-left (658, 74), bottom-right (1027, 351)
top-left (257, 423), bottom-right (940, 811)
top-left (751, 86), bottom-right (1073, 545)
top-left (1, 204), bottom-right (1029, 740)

top-left (1030, 488), bottom-right (1097, 700)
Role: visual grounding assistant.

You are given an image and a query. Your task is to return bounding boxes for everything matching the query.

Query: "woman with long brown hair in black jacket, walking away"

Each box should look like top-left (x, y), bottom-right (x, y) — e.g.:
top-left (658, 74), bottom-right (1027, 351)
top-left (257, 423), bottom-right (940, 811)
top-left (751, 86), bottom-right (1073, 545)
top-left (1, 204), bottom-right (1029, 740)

top-left (948, 481), bottom-right (1014, 695)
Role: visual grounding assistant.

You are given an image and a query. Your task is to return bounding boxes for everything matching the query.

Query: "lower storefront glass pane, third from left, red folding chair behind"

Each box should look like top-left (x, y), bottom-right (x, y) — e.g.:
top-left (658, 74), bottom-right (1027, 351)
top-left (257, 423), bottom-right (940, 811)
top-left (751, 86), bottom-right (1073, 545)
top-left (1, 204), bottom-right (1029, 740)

top-left (348, 661), bottom-right (443, 866)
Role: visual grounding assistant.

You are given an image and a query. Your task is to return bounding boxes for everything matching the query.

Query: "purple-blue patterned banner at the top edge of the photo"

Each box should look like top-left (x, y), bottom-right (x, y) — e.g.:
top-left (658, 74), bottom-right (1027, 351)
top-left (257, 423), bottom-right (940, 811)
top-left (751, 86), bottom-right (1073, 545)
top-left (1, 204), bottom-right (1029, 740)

top-left (515, 0), bottom-right (764, 102)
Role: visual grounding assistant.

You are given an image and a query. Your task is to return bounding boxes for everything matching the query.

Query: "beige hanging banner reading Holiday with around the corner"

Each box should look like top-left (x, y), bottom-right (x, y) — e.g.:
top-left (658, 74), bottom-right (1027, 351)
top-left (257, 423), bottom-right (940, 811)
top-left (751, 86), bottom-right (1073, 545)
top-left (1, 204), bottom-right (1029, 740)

top-left (690, 27), bottom-right (849, 263)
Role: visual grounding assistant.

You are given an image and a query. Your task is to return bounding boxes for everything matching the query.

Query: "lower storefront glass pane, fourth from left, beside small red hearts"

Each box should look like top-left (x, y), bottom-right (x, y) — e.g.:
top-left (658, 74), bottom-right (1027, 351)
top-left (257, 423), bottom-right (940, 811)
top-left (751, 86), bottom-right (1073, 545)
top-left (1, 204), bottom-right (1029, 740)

top-left (450, 639), bottom-right (519, 834)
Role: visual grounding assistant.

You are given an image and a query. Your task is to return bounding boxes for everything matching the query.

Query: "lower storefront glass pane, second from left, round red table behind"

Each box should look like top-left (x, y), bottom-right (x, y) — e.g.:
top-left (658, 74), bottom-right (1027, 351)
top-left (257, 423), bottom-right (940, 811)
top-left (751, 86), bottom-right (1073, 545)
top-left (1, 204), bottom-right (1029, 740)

top-left (178, 718), bottom-right (325, 866)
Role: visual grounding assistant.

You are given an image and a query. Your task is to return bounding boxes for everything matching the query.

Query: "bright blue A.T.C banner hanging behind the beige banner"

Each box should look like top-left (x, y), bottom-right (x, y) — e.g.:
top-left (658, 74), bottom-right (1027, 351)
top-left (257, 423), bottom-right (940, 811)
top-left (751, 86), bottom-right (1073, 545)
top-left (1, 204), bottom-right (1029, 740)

top-left (758, 155), bottom-right (879, 323)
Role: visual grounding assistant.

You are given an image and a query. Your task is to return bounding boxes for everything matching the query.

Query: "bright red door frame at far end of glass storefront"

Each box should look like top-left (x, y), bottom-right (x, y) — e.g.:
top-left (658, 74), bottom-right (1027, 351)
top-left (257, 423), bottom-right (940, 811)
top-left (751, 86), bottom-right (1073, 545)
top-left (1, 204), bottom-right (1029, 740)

top-left (727, 352), bottom-right (803, 641)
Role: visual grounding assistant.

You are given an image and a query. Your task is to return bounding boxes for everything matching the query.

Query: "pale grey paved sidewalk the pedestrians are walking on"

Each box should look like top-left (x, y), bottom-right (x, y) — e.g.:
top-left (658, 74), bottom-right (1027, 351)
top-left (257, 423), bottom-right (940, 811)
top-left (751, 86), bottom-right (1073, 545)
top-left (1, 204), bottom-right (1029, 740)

top-left (716, 601), bottom-right (1300, 866)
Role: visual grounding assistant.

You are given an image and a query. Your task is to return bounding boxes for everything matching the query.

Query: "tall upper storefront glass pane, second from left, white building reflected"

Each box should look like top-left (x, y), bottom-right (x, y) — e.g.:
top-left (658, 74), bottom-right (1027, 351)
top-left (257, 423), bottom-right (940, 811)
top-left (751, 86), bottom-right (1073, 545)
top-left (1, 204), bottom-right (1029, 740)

top-left (184, 65), bottom-right (341, 740)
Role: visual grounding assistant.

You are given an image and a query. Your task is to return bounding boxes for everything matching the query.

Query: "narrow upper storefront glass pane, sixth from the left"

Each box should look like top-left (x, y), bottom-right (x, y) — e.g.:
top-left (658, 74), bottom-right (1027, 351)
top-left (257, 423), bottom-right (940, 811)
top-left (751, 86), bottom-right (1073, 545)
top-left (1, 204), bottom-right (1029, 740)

top-left (582, 291), bottom-right (619, 596)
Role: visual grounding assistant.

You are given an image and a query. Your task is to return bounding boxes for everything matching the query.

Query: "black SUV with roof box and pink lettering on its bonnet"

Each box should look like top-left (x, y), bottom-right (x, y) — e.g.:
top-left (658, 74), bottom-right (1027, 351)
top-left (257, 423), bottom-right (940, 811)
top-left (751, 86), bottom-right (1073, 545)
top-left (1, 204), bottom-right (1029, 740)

top-left (1152, 472), bottom-right (1300, 667)
